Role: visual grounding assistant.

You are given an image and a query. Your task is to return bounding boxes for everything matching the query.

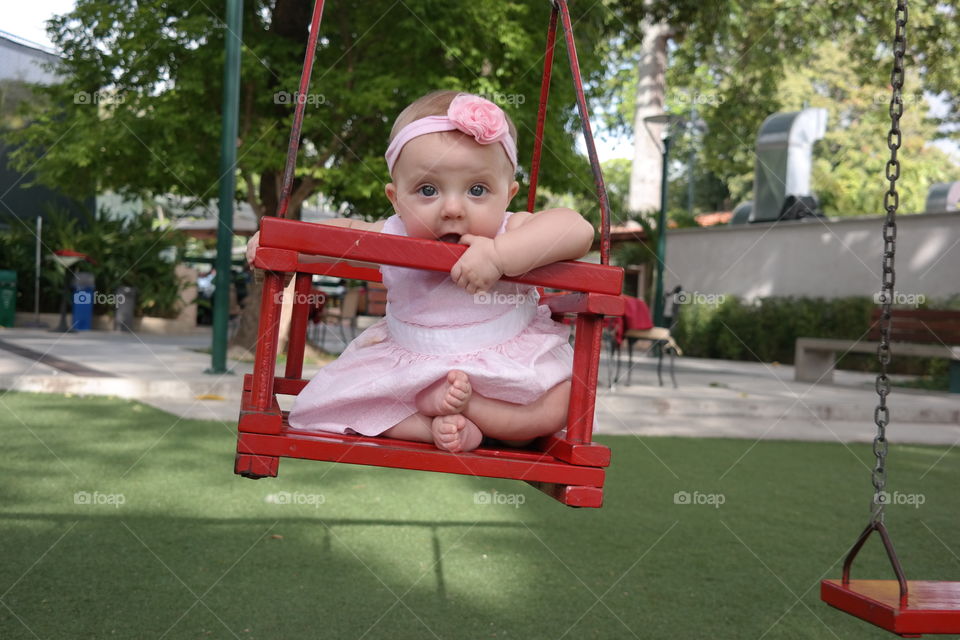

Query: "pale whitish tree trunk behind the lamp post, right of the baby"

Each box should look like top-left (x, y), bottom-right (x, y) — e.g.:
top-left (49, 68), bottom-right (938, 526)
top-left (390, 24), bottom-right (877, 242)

top-left (628, 22), bottom-right (670, 213)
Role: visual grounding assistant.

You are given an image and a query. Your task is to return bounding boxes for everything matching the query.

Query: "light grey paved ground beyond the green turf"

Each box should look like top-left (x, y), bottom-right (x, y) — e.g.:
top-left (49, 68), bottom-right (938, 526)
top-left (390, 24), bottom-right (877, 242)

top-left (0, 328), bottom-right (960, 445)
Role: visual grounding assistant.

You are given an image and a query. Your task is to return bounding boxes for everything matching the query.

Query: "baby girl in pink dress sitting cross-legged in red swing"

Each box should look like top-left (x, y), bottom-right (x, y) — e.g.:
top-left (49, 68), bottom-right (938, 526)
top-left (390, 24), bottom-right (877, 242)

top-left (247, 91), bottom-right (593, 452)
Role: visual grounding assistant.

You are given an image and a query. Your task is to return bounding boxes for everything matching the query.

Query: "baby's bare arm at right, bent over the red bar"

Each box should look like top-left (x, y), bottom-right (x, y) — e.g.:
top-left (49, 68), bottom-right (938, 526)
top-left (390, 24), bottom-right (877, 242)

top-left (450, 208), bottom-right (593, 293)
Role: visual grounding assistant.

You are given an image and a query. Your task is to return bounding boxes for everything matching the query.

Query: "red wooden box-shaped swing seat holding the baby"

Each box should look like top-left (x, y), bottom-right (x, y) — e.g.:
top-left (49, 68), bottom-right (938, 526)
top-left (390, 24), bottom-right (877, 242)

top-left (234, 218), bottom-right (623, 507)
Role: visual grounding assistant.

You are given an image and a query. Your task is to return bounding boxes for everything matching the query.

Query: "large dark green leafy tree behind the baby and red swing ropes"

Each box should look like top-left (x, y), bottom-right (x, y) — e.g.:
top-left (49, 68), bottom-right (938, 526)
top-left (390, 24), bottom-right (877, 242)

top-left (9, 0), bottom-right (628, 346)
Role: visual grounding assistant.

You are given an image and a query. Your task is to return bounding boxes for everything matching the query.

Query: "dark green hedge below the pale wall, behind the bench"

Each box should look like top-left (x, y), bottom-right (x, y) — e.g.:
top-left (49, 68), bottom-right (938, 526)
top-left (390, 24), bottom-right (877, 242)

top-left (674, 296), bottom-right (954, 375)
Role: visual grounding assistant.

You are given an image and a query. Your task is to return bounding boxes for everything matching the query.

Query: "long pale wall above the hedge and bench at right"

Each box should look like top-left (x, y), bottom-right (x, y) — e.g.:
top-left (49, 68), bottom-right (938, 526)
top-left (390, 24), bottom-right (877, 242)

top-left (664, 212), bottom-right (960, 300)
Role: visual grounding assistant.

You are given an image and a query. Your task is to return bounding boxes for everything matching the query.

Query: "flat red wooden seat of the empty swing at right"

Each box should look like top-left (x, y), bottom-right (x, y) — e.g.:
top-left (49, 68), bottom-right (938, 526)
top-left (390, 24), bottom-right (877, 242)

top-left (820, 580), bottom-right (960, 638)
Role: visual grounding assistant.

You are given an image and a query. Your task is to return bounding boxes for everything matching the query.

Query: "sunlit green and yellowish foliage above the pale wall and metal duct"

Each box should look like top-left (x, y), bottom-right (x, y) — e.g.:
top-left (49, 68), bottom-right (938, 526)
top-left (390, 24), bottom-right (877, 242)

top-left (604, 0), bottom-right (960, 215)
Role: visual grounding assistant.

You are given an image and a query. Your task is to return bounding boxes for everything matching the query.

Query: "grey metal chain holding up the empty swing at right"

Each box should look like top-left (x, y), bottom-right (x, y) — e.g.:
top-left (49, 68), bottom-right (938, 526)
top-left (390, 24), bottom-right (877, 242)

top-left (872, 0), bottom-right (907, 523)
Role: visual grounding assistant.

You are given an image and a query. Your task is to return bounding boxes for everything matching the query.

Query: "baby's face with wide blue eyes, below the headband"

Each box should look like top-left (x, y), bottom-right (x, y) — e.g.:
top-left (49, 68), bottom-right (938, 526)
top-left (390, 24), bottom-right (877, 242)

top-left (386, 131), bottom-right (520, 242)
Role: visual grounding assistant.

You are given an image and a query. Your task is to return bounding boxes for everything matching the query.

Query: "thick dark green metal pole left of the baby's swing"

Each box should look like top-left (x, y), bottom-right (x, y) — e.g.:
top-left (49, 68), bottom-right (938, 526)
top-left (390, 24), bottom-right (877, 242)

top-left (207, 0), bottom-right (243, 374)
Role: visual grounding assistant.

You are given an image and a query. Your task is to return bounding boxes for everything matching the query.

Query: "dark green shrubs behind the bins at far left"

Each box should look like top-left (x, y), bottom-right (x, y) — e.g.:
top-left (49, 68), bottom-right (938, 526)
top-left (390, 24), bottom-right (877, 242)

top-left (0, 211), bottom-right (186, 317)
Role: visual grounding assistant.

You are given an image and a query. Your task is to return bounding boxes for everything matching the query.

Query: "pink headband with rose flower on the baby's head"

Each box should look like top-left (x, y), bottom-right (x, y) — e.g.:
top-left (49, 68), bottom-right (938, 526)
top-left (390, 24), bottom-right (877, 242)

top-left (384, 93), bottom-right (517, 174)
